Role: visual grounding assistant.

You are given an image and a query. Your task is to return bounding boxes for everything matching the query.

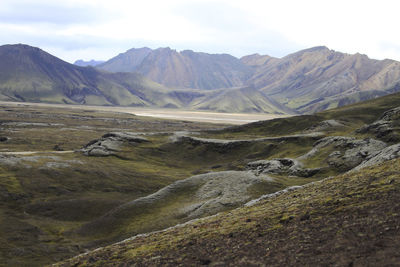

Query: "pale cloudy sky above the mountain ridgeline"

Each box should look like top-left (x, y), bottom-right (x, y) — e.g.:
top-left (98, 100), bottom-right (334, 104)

top-left (0, 0), bottom-right (400, 63)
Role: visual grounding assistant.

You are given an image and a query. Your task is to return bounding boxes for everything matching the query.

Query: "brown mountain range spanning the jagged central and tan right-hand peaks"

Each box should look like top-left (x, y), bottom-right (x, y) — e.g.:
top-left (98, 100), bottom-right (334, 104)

top-left (98, 46), bottom-right (400, 113)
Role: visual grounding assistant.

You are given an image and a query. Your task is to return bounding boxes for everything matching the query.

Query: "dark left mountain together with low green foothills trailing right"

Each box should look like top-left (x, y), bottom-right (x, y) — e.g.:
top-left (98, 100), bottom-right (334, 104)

top-left (0, 44), bottom-right (290, 114)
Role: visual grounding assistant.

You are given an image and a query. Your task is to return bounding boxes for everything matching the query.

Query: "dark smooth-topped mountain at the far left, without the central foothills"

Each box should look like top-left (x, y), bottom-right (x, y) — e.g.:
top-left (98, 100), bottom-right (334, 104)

top-left (0, 45), bottom-right (183, 106)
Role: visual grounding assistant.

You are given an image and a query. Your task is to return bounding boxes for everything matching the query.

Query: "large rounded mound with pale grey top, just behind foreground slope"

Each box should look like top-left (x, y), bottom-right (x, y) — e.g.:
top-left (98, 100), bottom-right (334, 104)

top-left (79, 171), bottom-right (272, 238)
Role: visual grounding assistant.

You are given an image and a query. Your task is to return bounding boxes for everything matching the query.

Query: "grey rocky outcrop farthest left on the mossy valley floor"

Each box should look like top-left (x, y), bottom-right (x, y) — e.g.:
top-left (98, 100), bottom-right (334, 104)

top-left (81, 132), bottom-right (148, 157)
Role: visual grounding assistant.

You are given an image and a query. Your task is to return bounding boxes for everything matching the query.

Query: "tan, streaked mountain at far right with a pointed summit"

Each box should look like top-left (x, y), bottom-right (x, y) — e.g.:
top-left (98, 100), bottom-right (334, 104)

top-left (248, 47), bottom-right (400, 112)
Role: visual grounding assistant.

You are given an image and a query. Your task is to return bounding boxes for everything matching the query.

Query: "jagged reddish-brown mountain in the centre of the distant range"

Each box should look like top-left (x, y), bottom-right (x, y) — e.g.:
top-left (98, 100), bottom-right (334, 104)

top-left (98, 47), bottom-right (253, 89)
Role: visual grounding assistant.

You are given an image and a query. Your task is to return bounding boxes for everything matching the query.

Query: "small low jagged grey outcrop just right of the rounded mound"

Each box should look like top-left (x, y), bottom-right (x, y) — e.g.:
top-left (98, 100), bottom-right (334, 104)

top-left (246, 158), bottom-right (320, 177)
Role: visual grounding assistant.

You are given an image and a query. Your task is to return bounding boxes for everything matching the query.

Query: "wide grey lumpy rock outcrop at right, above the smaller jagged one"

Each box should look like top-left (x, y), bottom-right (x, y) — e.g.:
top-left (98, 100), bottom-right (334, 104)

top-left (298, 136), bottom-right (387, 171)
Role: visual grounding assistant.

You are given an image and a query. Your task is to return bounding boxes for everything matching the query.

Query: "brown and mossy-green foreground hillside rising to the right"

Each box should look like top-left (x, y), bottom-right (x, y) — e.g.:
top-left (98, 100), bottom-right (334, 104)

top-left (57, 160), bottom-right (400, 266)
